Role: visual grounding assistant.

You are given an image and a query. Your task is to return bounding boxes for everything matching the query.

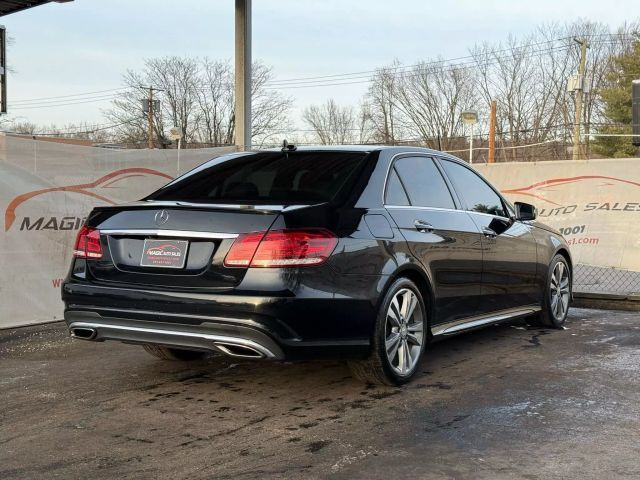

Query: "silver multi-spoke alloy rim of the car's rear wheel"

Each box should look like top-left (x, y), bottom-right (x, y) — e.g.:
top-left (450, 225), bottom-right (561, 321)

top-left (385, 288), bottom-right (424, 376)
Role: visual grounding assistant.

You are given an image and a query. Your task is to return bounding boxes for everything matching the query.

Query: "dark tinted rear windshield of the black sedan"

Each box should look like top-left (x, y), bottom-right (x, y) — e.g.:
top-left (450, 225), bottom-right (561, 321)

top-left (147, 152), bottom-right (368, 204)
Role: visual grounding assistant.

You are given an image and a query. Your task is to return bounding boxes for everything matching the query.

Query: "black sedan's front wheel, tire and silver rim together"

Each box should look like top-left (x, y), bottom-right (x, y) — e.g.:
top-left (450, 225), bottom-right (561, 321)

top-left (527, 255), bottom-right (572, 329)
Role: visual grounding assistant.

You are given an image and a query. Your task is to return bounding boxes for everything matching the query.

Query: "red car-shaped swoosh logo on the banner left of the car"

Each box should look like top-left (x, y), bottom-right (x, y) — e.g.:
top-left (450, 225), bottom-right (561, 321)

top-left (4, 168), bottom-right (173, 232)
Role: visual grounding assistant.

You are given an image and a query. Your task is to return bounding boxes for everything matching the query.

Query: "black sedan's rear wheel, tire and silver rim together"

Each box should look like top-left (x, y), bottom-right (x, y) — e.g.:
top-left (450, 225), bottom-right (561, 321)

top-left (349, 278), bottom-right (428, 385)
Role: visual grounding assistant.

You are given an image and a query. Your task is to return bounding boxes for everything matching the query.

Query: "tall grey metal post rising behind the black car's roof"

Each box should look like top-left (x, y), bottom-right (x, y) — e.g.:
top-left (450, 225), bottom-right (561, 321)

top-left (235, 0), bottom-right (251, 151)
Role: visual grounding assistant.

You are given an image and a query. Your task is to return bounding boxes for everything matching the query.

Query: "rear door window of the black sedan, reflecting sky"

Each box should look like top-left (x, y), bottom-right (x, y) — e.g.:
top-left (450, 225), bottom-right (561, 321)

top-left (394, 157), bottom-right (455, 208)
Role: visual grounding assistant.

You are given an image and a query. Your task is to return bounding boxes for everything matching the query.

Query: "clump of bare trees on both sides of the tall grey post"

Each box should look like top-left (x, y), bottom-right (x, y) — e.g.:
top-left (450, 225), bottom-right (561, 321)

top-left (104, 57), bottom-right (293, 145)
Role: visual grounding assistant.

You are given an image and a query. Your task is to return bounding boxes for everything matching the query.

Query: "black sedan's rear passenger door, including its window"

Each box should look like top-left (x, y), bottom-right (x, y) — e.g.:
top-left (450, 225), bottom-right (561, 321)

top-left (385, 154), bottom-right (482, 324)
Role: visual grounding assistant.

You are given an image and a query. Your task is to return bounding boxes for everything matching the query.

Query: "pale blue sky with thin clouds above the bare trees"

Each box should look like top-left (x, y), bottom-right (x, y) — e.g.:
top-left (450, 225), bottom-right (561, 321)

top-left (5, 0), bottom-right (638, 126)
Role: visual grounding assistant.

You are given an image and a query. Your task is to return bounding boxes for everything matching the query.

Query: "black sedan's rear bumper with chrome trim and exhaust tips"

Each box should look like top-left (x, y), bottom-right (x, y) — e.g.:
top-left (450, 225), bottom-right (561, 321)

top-left (62, 277), bottom-right (380, 360)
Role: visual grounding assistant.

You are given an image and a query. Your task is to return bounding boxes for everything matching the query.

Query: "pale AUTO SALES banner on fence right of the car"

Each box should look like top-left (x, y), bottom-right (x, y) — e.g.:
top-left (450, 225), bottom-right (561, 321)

top-left (474, 158), bottom-right (640, 272)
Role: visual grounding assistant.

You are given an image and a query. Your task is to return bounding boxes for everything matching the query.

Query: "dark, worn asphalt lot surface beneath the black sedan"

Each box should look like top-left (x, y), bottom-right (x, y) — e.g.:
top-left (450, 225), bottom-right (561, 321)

top-left (0, 309), bottom-right (640, 480)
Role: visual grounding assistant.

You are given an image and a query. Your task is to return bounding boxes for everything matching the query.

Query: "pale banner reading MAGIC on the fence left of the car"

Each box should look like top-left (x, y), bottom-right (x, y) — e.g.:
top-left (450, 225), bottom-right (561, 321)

top-left (0, 136), bottom-right (234, 328)
